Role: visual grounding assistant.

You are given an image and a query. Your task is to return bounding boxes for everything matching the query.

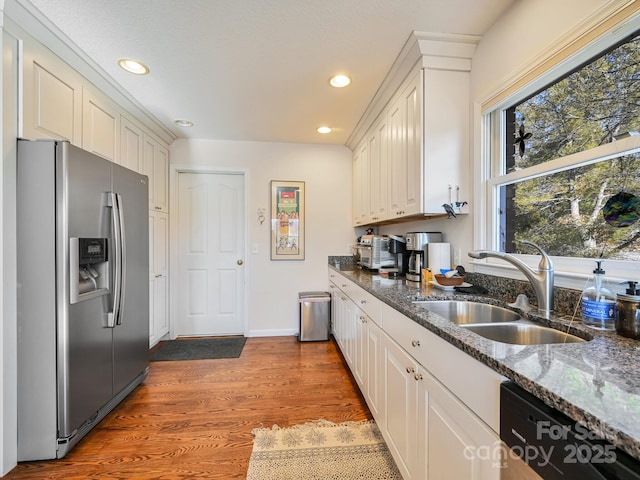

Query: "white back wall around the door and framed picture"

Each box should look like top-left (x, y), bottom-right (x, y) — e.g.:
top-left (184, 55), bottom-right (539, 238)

top-left (170, 139), bottom-right (354, 336)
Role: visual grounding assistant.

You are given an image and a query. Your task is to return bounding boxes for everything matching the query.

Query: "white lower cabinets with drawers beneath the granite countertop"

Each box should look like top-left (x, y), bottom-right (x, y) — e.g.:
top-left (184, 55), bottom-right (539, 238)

top-left (330, 272), bottom-right (501, 480)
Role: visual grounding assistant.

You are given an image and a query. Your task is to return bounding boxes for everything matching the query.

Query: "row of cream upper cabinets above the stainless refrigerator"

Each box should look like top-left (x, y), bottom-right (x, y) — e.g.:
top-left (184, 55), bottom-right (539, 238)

top-left (19, 27), bottom-right (169, 189)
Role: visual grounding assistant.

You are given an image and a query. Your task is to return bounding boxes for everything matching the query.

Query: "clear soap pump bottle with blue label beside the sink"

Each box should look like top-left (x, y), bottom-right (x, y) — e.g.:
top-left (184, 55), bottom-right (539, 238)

top-left (582, 260), bottom-right (616, 330)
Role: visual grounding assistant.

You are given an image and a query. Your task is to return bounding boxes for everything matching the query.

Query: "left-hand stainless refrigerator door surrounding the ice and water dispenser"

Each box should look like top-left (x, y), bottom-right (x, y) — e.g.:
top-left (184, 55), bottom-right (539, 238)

top-left (56, 142), bottom-right (113, 438)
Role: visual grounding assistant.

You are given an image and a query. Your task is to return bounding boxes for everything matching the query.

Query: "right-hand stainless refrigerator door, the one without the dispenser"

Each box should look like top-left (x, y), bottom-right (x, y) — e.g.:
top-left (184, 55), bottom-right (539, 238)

top-left (112, 164), bottom-right (149, 394)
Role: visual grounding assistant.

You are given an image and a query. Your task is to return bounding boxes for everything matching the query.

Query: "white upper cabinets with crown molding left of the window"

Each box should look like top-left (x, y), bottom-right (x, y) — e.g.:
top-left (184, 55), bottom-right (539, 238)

top-left (350, 33), bottom-right (478, 226)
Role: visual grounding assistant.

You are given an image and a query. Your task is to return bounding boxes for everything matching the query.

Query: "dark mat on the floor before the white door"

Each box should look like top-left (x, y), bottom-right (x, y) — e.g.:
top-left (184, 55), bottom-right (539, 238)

top-left (151, 337), bottom-right (247, 362)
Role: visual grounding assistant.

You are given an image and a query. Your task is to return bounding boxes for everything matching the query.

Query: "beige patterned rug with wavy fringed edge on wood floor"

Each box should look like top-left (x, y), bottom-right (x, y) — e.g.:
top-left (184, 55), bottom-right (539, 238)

top-left (247, 420), bottom-right (402, 480)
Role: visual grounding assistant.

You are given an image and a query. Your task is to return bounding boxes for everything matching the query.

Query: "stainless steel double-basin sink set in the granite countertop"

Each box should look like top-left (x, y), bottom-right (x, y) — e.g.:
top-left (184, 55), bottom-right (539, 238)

top-left (414, 300), bottom-right (585, 345)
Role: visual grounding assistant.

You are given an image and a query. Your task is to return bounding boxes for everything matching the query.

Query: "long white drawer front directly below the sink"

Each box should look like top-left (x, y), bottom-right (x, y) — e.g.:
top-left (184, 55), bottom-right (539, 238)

top-left (382, 305), bottom-right (504, 432)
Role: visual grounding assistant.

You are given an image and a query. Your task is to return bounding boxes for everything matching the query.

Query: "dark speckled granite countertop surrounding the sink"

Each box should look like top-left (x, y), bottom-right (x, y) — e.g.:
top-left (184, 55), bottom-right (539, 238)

top-left (329, 257), bottom-right (640, 460)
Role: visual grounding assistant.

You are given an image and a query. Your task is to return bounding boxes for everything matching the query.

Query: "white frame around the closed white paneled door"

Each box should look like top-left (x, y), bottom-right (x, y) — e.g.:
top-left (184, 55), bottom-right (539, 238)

top-left (169, 165), bottom-right (250, 340)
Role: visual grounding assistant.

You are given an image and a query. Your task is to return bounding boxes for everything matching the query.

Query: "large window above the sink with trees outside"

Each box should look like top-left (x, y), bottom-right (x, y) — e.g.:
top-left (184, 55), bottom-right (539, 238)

top-left (484, 21), bottom-right (640, 279)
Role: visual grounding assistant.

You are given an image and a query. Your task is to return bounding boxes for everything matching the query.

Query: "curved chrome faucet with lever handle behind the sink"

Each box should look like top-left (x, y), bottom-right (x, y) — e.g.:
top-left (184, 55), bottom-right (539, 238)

top-left (469, 240), bottom-right (553, 316)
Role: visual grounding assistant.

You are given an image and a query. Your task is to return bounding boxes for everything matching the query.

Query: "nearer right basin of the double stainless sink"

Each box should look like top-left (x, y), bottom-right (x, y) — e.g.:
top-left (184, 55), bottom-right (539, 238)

top-left (462, 320), bottom-right (586, 345)
